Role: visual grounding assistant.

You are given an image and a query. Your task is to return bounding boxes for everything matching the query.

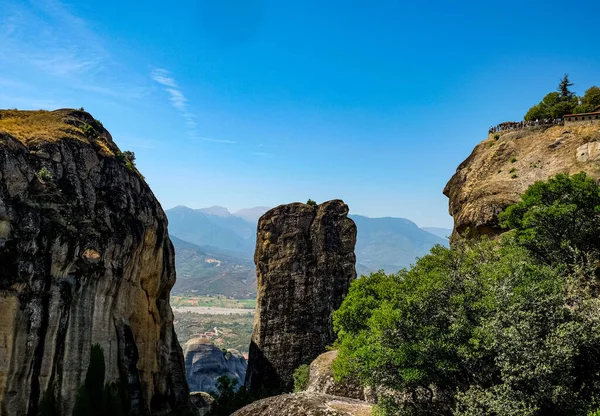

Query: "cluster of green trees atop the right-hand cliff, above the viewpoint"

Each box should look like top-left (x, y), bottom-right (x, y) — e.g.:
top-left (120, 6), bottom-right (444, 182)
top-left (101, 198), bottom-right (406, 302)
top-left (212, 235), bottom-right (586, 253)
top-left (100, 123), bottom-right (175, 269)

top-left (525, 74), bottom-right (600, 121)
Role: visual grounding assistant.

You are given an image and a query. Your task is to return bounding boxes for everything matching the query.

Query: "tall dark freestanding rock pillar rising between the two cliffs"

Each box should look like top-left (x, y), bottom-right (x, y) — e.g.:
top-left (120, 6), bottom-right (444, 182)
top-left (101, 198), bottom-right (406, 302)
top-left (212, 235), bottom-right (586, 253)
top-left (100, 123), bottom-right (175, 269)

top-left (246, 200), bottom-right (356, 394)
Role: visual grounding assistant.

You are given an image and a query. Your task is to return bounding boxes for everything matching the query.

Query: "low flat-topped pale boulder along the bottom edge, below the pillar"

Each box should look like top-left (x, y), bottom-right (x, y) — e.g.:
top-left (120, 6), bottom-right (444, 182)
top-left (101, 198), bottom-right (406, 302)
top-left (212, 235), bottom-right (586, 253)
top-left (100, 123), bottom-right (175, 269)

top-left (231, 392), bottom-right (373, 416)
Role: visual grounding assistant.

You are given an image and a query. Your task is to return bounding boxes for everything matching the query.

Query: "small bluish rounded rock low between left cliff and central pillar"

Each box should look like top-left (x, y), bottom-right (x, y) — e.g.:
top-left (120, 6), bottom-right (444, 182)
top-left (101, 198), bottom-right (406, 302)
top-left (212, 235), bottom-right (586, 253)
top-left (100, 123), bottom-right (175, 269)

top-left (185, 338), bottom-right (247, 392)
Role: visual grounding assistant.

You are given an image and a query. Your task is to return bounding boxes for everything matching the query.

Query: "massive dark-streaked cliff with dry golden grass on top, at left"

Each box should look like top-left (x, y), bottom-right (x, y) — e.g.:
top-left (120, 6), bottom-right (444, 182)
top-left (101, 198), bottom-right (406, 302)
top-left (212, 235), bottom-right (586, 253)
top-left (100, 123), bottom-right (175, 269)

top-left (0, 110), bottom-right (189, 416)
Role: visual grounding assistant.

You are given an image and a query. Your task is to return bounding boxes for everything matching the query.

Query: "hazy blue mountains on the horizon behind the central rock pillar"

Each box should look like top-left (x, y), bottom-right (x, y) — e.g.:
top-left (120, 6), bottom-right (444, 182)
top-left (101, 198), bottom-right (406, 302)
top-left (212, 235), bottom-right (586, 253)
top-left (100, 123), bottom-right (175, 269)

top-left (166, 206), bottom-right (452, 298)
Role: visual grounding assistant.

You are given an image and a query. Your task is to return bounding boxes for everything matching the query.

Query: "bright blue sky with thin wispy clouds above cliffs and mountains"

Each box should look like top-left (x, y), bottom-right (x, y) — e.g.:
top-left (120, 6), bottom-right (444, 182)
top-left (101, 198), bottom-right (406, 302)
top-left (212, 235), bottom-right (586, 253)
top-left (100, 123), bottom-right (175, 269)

top-left (0, 0), bottom-right (600, 226)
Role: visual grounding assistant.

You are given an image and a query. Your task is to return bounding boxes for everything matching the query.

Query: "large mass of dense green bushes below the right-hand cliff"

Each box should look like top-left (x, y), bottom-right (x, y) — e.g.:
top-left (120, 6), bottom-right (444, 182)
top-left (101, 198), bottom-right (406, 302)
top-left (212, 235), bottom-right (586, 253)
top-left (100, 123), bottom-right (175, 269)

top-left (334, 173), bottom-right (600, 416)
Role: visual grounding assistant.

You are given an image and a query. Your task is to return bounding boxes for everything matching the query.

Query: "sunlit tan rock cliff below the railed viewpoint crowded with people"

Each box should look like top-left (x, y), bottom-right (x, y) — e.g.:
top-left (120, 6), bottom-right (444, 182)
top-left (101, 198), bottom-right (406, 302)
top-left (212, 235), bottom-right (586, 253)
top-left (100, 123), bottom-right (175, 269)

top-left (444, 124), bottom-right (600, 240)
